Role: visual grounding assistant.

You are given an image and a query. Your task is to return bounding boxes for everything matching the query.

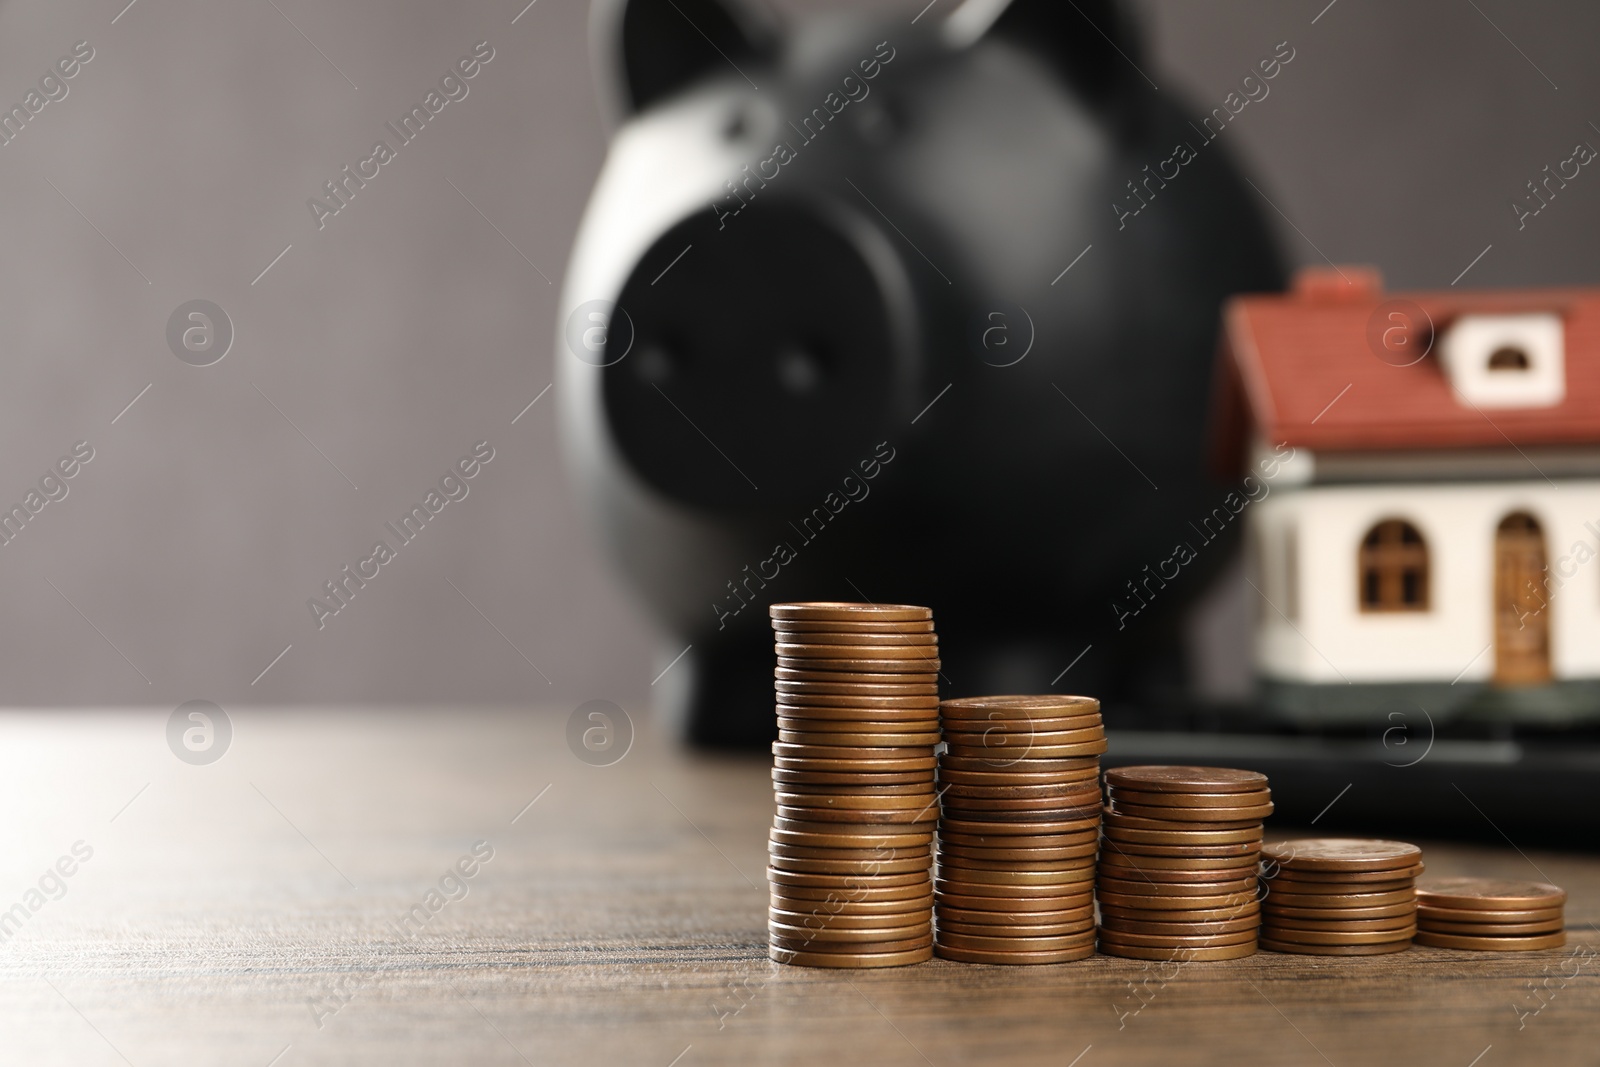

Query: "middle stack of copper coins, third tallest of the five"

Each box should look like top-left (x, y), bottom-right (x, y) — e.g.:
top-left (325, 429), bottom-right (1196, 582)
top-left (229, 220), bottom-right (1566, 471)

top-left (1096, 766), bottom-right (1272, 961)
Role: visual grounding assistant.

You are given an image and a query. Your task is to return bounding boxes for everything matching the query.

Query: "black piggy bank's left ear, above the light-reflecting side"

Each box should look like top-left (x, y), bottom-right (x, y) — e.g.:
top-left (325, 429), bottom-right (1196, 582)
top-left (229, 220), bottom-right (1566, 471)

top-left (589, 0), bottom-right (778, 126)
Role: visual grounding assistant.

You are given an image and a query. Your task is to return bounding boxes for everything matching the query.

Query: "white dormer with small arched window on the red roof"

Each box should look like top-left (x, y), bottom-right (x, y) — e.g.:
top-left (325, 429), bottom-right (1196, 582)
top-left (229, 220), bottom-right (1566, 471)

top-left (1438, 312), bottom-right (1566, 408)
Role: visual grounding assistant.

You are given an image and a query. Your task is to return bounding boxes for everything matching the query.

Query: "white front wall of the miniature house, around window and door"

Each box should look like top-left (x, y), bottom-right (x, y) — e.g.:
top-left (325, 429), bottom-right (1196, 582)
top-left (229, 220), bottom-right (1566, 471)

top-left (1250, 480), bottom-right (1600, 683)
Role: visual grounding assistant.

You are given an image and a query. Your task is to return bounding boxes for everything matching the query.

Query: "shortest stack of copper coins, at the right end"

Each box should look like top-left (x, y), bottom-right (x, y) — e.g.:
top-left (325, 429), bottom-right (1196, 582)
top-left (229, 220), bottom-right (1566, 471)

top-left (1416, 878), bottom-right (1566, 952)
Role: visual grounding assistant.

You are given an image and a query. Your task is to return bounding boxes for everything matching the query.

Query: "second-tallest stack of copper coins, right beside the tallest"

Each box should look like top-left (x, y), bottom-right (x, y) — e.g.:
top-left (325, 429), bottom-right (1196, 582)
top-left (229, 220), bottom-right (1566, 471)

top-left (934, 696), bottom-right (1106, 963)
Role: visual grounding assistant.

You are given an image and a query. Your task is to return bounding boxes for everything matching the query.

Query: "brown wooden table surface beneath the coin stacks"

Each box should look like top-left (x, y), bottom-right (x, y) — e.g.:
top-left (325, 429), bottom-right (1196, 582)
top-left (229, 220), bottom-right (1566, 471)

top-left (0, 710), bottom-right (1600, 1067)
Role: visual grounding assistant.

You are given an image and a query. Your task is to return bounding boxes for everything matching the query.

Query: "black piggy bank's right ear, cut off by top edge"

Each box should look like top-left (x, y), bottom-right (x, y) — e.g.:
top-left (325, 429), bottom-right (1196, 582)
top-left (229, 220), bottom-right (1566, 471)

top-left (944, 0), bottom-right (1152, 104)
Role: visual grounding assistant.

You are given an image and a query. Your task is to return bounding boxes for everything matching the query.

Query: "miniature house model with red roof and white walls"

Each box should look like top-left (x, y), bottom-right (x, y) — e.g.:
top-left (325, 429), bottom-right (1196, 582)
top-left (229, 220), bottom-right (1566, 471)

top-left (1216, 267), bottom-right (1600, 723)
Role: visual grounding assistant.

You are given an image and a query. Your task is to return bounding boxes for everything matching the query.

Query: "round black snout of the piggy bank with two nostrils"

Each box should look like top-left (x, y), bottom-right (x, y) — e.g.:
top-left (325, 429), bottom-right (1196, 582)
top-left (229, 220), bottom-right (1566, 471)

top-left (602, 202), bottom-right (906, 512)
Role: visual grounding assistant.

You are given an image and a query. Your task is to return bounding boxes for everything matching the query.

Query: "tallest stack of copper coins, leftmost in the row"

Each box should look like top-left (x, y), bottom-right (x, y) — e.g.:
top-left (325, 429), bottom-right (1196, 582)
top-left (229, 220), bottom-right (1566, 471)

top-left (766, 603), bottom-right (939, 968)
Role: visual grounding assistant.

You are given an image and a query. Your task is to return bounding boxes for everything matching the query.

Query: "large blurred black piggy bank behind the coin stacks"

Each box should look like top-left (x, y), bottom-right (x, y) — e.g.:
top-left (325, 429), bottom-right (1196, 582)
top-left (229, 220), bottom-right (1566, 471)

top-left (557, 0), bottom-right (1291, 745)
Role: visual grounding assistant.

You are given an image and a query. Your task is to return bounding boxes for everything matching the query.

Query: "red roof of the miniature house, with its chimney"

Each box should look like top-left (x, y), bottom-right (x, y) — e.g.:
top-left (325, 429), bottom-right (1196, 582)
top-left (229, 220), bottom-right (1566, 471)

top-left (1216, 267), bottom-right (1600, 466)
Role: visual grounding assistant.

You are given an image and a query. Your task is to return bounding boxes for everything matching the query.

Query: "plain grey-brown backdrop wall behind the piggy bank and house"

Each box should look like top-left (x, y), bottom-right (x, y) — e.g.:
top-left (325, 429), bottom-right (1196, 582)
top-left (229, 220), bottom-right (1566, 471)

top-left (0, 0), bottom-right (1600, 709)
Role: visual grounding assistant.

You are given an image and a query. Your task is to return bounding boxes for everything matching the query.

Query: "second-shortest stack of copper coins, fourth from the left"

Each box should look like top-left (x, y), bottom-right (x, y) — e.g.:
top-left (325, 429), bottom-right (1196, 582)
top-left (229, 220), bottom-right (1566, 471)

top-left (1261, 838), bottom-right (1422, 957)
